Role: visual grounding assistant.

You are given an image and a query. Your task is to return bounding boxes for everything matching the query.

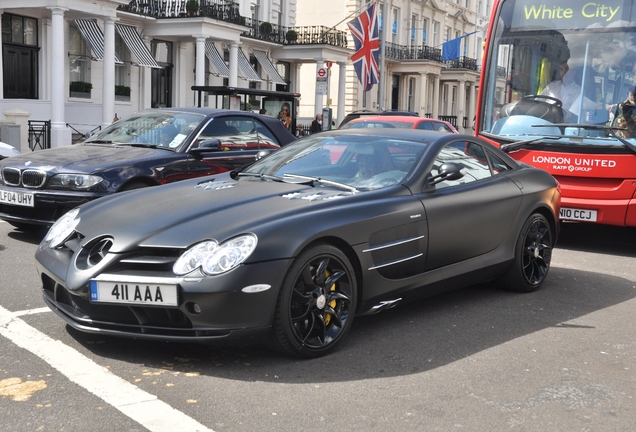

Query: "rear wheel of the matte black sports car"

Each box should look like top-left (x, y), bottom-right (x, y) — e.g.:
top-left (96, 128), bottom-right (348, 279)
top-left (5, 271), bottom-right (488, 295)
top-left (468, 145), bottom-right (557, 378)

top-left (499, 213), bottom-right (554, 292)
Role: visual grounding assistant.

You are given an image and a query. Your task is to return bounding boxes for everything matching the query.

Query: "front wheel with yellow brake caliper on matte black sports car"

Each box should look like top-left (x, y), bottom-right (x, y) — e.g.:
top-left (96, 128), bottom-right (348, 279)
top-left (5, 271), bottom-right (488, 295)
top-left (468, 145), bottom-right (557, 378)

top-left (269, 244), bottom-right (357, 358)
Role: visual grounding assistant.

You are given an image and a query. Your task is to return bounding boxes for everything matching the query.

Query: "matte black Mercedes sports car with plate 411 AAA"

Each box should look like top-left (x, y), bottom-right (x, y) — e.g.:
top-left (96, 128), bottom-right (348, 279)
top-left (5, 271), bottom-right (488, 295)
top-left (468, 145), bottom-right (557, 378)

top-left (36, 129), bottom-right (560, 357)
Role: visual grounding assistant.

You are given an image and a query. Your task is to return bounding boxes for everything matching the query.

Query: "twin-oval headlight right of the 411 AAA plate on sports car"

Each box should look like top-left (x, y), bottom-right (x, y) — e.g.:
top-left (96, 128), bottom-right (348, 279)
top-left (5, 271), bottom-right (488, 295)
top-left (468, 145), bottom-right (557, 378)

top-left (172, 234), bottom-right (258, 276)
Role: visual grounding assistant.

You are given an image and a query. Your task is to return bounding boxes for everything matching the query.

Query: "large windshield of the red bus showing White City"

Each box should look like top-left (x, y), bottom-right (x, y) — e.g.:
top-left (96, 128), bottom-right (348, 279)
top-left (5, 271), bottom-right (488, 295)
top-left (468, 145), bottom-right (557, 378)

top-left (478, 0), bottom-right (636, 146)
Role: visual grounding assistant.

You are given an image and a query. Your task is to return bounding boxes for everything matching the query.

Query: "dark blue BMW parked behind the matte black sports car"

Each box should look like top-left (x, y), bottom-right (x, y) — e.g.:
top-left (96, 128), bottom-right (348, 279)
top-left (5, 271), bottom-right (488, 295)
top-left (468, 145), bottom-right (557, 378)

top-left (0, 108), bottom-right (296, 228)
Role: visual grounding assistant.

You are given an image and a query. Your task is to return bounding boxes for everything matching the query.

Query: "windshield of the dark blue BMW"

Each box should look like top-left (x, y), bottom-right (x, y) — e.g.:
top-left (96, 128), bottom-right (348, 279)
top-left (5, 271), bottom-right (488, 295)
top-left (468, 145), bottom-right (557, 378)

top-left (85, 111), bottom-right (205, 149)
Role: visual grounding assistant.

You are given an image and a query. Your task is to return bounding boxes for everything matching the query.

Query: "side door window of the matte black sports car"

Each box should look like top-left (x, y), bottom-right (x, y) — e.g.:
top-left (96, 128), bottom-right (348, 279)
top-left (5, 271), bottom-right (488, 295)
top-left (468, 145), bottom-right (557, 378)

top-left (432, 141), bottom-right (492, 188)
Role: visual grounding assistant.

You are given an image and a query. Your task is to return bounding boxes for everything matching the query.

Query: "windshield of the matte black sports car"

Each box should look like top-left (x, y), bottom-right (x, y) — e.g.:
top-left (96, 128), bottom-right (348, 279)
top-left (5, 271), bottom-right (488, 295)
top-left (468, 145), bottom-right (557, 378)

top-left (246, 133), bottom-right (428, 190)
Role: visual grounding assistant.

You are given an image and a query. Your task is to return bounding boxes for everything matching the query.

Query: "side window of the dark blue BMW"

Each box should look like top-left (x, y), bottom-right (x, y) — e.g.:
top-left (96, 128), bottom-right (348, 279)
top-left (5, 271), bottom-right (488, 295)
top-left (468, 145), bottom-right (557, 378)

top-left (195, 117), bottom-right (280, 150)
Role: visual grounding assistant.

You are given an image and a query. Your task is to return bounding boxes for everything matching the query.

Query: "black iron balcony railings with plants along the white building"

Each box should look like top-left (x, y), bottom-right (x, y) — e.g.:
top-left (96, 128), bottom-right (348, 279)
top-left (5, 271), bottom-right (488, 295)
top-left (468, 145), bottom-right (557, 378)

top-left (117, 0), bottom-right (347, 48)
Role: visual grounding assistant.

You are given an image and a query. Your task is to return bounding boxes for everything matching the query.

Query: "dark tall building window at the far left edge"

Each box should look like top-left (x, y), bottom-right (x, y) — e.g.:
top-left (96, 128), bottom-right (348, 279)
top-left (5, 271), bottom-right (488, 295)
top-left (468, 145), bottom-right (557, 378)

top-left (2, 13), bottom-right (39, 99)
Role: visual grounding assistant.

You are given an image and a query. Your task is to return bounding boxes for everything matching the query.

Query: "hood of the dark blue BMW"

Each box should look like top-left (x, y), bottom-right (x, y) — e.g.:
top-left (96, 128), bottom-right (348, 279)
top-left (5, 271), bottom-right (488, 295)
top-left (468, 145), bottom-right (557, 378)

top-left (4, 144), bottom-right (168, 174)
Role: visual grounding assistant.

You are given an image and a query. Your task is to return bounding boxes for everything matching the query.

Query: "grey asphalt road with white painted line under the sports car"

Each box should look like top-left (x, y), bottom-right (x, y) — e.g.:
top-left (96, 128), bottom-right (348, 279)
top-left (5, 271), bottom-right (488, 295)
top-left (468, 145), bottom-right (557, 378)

top-left (0, 222), bottom-right (636, 432)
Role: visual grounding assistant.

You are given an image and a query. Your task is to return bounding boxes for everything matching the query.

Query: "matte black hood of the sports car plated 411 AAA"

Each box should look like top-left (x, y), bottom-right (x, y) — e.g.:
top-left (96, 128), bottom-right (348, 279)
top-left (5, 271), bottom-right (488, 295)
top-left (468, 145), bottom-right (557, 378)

top-left (77, 174), bottom-right (355, 253)
